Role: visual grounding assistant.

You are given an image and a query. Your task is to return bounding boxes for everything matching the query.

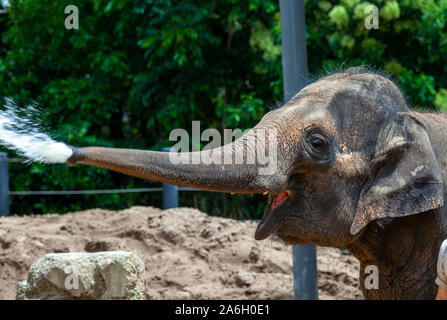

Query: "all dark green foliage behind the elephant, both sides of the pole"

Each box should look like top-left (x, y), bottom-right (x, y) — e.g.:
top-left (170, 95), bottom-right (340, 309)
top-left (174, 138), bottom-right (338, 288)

top-left (0, 0), bottom-right (447, 218)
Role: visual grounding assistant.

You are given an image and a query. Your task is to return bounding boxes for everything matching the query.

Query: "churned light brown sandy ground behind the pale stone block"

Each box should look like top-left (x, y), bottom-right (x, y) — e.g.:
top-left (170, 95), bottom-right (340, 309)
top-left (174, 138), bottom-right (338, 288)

top-left (0, 207), bottom-right (362, 299)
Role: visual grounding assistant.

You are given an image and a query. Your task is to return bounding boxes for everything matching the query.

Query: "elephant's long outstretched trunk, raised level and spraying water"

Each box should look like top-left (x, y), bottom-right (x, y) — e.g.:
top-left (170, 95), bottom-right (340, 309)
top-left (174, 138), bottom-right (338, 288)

top-left (67, 129), bottom-right (287, 193)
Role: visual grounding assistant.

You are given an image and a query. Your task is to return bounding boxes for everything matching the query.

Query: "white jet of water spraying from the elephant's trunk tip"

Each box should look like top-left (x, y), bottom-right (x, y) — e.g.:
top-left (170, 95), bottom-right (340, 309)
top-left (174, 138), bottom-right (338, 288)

top-left (0, 98), bottom-right (73, 163)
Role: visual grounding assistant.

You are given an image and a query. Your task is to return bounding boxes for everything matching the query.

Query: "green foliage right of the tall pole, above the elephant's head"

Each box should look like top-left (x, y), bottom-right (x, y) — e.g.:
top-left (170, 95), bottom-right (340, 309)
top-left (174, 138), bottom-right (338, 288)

top-left (306, 0), bottom-right (447, 109)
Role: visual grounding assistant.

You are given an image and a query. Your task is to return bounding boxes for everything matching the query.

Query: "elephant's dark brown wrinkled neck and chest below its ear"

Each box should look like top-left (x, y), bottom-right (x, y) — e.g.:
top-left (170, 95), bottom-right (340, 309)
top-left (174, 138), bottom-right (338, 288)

top-left (346, 210), bottom-right (440, 299)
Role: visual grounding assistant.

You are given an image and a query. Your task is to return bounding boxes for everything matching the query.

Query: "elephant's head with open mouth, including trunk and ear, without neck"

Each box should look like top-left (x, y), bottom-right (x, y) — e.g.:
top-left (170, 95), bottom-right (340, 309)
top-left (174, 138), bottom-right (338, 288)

top-left (67, 68), bottom-right (443, 246)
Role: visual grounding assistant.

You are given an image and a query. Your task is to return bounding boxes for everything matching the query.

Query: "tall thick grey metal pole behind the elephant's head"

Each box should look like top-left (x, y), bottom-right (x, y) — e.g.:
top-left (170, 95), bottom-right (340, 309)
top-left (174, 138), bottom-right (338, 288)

top-left (279, 0), bottom-right (318, 300)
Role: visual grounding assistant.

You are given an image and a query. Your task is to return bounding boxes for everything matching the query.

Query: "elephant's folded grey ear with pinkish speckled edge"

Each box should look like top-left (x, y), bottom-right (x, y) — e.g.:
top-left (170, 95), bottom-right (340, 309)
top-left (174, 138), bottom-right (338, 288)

top-left (351, 112), bottom-right (444, 235)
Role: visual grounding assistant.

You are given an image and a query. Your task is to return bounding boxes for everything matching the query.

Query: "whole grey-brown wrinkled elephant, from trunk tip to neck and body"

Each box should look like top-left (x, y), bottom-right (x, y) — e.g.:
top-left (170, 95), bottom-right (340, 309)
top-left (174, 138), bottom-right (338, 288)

top-left (67, 68), bottom-right (447, 299)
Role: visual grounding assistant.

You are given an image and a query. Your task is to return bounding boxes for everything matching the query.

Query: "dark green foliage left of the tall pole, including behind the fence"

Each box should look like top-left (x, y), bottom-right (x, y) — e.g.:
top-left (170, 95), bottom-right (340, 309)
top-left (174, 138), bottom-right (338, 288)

top-left (0, 0), bottom-right (282, 217)
